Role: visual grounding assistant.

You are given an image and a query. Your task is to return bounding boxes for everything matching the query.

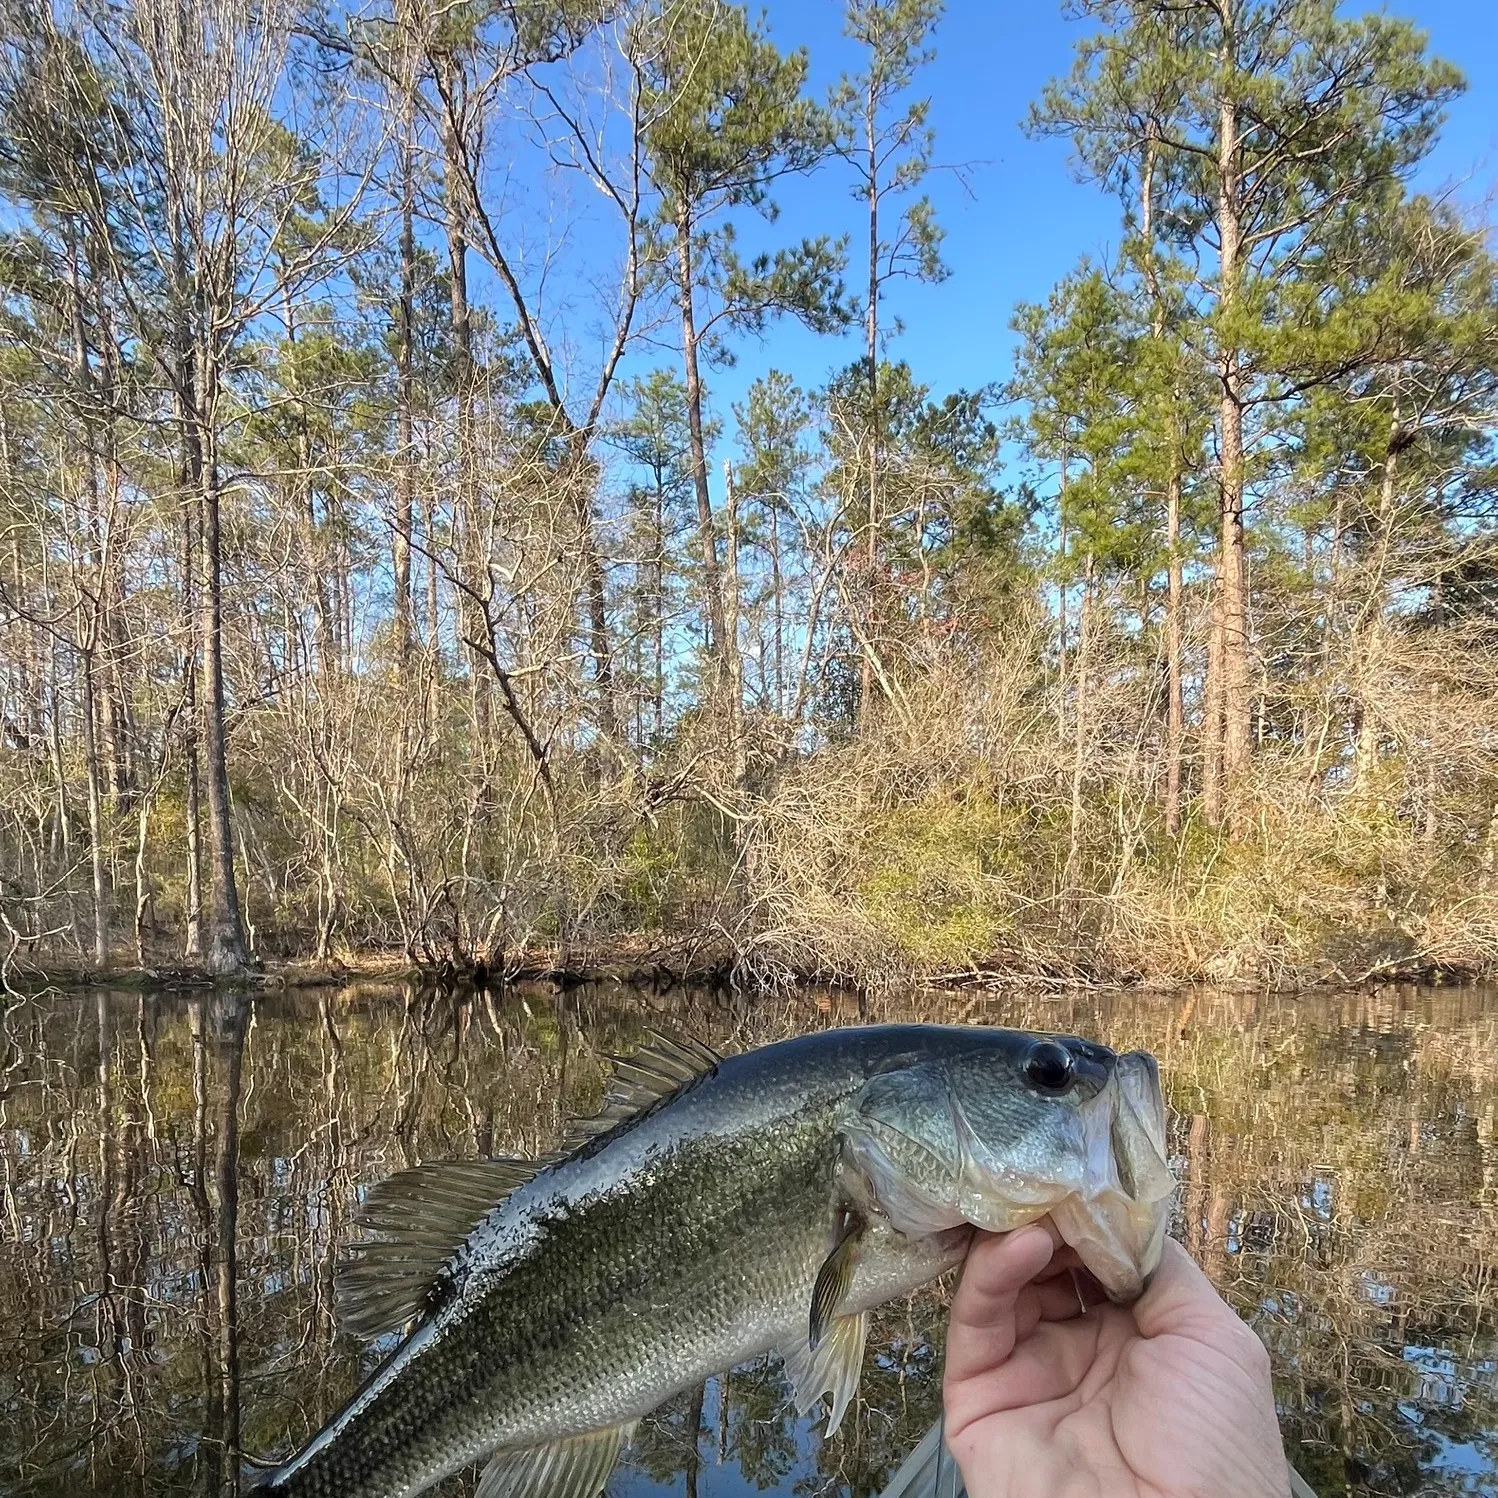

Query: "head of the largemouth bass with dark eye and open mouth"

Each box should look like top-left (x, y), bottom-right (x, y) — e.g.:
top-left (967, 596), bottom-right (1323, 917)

top-left (842, 1031), bottom-right (1174, 1302)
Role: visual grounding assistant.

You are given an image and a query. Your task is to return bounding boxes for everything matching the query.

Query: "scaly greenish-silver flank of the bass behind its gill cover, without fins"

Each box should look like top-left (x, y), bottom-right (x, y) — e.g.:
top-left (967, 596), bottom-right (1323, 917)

top-left (280, 1036), bottom-right (863, 1498)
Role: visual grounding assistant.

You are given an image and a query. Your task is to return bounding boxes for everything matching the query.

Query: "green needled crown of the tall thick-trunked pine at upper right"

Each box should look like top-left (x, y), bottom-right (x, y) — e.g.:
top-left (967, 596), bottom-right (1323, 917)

top-left (1031, 0), bottom-right (1462, 443)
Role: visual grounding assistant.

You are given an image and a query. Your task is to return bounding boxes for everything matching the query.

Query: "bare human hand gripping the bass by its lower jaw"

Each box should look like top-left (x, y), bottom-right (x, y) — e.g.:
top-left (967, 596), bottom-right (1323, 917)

top-left (944, 1222), bottom-right (1290, 1498)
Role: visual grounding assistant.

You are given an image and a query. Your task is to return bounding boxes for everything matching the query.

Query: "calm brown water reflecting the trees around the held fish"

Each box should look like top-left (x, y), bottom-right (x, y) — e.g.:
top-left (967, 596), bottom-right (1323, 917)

top-left (0, 989), bottom-right (1498, 1498)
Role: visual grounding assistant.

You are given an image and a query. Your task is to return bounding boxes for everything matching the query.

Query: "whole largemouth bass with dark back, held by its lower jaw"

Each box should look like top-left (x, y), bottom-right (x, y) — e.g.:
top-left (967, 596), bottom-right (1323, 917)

top-left (270, 1025), bottom-right (1173, 1498)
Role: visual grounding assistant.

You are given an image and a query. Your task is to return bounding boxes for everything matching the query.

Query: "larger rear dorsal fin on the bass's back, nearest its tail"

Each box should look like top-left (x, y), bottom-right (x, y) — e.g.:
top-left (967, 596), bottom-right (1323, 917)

top-left (334, 1158), bottom-right (551, 1336)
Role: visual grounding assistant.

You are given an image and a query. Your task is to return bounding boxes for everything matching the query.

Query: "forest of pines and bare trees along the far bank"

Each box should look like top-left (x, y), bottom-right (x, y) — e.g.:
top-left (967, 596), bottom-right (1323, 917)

top-left (0, 0), bottom-right (1498, 984)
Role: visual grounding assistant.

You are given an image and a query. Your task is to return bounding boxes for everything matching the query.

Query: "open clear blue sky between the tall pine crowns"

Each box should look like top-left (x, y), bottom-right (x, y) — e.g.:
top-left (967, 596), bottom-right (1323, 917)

top-left (649, 0), bottom-right (1498, 449)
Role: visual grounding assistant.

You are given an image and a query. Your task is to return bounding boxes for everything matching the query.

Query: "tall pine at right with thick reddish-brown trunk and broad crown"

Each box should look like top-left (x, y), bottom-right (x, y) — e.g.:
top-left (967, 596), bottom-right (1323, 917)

top-left (1031, 0), bottom-right (1459, 827)
